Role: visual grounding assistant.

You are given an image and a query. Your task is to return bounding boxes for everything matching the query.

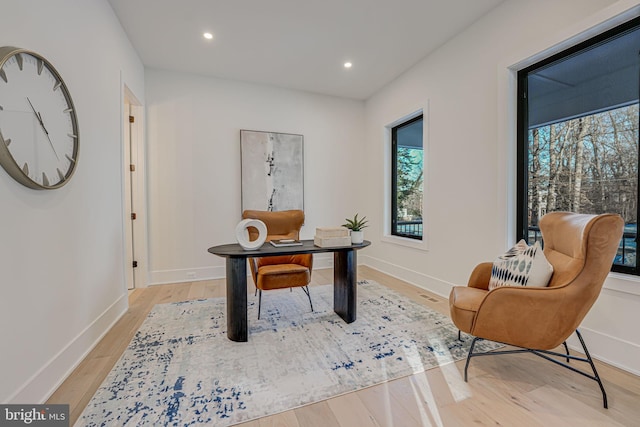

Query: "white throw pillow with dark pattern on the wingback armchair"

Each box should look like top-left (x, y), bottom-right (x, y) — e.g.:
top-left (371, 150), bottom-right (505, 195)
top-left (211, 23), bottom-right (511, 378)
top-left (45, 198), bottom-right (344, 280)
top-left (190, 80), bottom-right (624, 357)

top-left (489, 240), bottom-right (553, 290)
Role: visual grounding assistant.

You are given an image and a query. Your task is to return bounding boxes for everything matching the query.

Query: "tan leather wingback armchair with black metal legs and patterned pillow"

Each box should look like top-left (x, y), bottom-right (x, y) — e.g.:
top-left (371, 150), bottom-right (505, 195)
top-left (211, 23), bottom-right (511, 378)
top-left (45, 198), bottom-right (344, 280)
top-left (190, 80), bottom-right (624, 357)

top-left (449, 212), bottom-right (624, 408)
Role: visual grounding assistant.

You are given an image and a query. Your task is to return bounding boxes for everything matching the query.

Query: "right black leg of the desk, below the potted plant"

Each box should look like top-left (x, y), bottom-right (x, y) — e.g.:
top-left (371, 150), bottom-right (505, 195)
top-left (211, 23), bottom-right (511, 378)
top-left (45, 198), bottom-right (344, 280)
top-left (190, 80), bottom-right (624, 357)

top-left (333, 250), bottom-right (358, 323)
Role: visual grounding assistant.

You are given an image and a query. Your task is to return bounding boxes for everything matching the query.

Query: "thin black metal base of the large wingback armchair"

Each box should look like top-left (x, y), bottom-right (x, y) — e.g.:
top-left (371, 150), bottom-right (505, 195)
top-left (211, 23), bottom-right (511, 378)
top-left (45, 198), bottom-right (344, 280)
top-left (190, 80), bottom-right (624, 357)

top-left (464, 329), bottom-right (609, 409)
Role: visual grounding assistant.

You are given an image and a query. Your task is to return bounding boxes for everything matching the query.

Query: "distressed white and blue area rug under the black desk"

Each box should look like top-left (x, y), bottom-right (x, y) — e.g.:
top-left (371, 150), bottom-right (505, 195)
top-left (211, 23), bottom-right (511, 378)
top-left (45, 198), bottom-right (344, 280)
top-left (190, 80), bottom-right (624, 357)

top-left (76, 281), bottom-right (499, 426)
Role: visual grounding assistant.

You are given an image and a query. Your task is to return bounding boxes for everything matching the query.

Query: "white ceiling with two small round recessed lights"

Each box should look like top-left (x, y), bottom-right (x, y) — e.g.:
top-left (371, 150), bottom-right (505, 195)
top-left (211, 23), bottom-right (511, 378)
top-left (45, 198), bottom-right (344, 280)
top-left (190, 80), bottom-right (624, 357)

top-left (109, 0), bottom-right (504, 99)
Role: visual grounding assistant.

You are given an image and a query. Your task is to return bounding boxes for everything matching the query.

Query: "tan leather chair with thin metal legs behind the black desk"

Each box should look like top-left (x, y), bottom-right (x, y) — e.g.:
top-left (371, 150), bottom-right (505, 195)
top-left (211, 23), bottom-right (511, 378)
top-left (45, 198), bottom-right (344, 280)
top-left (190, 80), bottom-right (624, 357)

top-left (242, 210), bottom-right (313, 319)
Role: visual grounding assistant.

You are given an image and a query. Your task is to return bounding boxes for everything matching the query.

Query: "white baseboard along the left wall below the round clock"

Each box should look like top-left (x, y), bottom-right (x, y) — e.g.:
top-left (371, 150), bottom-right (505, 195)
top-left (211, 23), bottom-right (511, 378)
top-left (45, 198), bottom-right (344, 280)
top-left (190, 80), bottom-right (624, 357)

top-left (7, 293), bottom-right (129, 403)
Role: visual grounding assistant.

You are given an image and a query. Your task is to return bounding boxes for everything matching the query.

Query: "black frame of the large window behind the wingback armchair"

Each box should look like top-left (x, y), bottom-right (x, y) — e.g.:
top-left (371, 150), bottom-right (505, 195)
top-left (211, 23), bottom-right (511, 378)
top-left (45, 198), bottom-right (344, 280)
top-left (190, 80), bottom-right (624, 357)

top-left (516, 17), bottom-right (640, 276)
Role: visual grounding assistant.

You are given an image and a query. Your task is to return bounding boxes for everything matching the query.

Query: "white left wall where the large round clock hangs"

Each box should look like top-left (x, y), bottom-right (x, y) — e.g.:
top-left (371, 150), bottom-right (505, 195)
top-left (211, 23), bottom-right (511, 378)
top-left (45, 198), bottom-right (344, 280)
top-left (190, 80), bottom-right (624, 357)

top-left (0, 0), bottom-right (144, 403)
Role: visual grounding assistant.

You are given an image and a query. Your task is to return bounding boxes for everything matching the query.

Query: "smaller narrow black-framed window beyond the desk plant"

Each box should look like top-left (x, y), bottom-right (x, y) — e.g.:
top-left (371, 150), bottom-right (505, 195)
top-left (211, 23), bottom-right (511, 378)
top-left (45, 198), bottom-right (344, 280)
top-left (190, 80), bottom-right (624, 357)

top-left (391, 115), bottom-right (424, 240)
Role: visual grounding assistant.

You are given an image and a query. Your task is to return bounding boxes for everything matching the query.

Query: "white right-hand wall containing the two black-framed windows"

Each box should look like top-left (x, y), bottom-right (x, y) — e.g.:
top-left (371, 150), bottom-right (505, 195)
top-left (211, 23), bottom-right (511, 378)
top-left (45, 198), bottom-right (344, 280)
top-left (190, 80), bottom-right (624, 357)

top-left (363, 0), bottom-right (640, 373)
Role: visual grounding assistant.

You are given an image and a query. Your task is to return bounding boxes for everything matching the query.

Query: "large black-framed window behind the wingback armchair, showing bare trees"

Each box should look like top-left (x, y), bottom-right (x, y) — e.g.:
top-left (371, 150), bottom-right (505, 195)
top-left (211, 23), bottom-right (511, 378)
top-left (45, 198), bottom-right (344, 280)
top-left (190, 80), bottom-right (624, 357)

top-left (517, 18), bottom-right (640, 275)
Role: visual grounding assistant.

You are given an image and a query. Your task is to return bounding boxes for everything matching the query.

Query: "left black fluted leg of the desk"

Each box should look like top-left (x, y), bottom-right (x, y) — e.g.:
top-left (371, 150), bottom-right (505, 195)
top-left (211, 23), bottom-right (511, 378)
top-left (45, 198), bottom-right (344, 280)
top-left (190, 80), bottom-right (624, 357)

top-left (227, 257), bottom-right (248, 342)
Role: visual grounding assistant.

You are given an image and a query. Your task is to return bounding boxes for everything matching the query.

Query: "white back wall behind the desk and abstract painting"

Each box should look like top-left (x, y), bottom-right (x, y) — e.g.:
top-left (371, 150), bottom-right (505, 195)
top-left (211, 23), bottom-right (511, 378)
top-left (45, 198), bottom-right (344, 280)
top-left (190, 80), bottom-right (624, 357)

top-left (145, 69), bottom-right (365, 284)
